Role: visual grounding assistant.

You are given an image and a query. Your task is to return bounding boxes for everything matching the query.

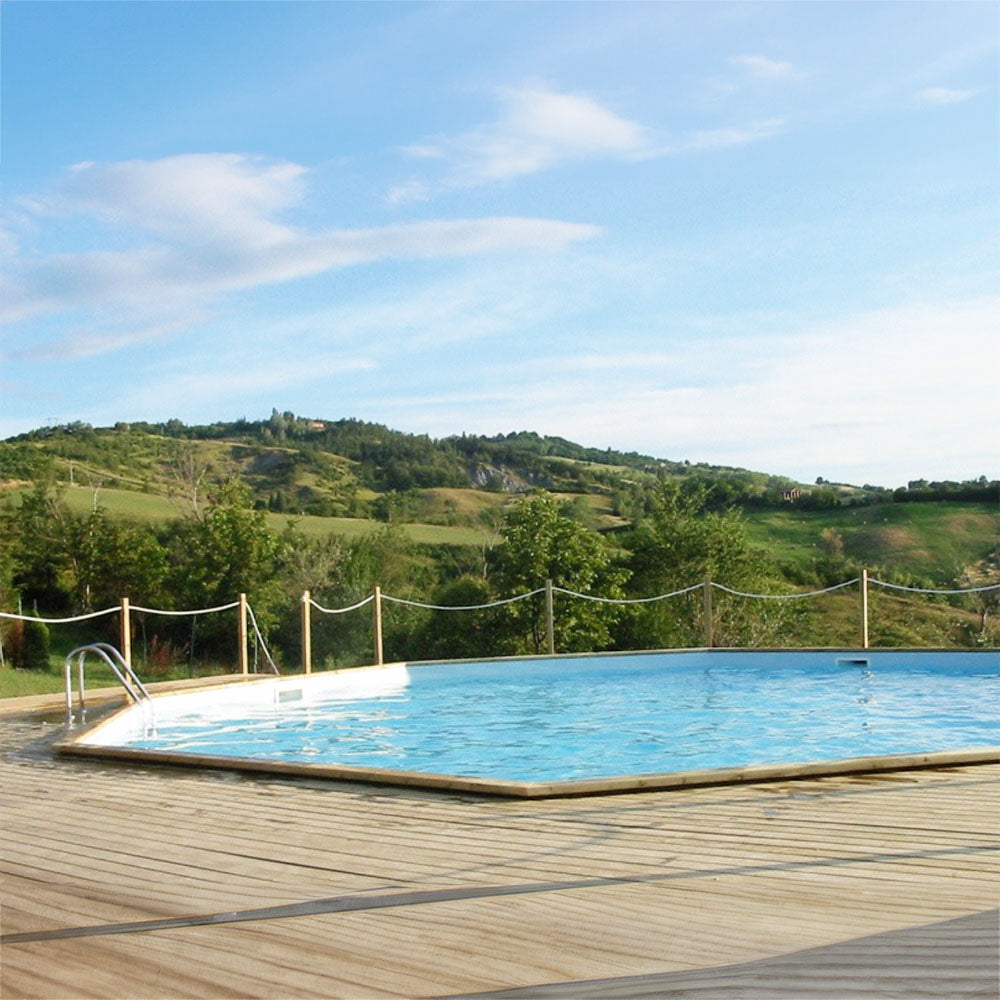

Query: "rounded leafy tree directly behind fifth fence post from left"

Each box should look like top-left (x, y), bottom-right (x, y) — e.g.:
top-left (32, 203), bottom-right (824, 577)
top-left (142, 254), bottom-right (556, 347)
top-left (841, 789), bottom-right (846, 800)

top-left (489, 493), bottom-right (627, 653)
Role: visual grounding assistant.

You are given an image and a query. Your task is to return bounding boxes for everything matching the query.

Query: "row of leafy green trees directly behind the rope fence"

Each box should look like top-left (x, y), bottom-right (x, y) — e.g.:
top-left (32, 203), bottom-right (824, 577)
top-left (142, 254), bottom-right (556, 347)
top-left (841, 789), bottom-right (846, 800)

top-left (0, 481), bottom-right (808, 668)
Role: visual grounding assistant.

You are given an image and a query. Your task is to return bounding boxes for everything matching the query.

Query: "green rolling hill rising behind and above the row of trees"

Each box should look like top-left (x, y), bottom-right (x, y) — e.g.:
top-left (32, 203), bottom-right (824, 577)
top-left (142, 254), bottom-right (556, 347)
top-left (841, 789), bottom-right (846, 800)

top-left (0, 411), bottom-right (998, 585)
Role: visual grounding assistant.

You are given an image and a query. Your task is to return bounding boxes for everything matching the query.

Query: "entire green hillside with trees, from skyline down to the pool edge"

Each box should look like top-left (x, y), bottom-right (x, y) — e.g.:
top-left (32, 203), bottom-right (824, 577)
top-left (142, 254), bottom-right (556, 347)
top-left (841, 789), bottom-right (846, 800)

top-left (0, 412), bottom-right (1000, 684)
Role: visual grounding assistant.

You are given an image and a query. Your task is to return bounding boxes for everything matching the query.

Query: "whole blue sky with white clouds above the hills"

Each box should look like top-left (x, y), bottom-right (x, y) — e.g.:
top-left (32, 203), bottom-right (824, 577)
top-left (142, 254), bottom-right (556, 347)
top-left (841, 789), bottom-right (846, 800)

top-left (0, 0), bottom-right (1000, 486)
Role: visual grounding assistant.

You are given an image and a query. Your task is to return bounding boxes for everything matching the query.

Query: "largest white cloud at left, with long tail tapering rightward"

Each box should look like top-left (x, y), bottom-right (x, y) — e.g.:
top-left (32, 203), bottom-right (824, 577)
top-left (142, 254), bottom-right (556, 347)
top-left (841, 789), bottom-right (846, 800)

top-left (2, 154), bottom-right (598, 357)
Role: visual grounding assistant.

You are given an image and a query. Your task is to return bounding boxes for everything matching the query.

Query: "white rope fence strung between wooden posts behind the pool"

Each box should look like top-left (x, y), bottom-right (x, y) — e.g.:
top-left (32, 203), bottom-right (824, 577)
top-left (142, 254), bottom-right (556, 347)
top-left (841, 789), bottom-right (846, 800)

top-left (0, 570), bottom-right (1000, 674)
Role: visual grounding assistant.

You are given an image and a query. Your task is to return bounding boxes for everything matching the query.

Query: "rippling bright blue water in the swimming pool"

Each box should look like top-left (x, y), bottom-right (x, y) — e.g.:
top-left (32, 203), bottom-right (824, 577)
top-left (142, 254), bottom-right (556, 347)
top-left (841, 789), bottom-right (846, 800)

top-left (95, 651), bottom-right (1000, 781)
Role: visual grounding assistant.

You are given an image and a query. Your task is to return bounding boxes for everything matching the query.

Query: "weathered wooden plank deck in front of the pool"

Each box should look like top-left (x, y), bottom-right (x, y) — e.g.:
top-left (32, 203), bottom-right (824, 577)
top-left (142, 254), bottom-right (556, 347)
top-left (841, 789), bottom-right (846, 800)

top-left (0, 704), bottom-right (1000, 1000)
